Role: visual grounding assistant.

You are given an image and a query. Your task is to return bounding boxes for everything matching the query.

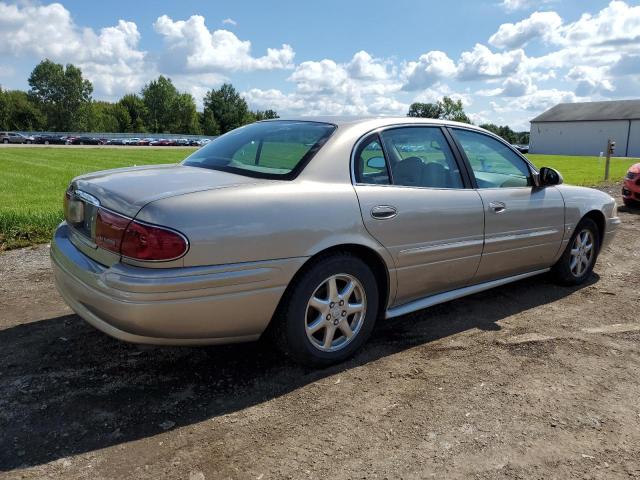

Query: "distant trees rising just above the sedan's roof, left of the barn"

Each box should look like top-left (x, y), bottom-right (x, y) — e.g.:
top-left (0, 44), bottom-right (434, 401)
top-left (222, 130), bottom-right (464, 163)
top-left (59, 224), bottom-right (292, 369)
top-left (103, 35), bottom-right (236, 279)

top-left (407, 97), bottom-right (529, 145)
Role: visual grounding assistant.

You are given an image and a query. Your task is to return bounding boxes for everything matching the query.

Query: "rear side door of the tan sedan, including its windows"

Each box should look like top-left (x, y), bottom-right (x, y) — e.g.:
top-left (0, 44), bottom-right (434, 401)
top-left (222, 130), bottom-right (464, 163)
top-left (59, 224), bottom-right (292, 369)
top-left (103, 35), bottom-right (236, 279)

top-left (353, 126), bottom-right (484, 304)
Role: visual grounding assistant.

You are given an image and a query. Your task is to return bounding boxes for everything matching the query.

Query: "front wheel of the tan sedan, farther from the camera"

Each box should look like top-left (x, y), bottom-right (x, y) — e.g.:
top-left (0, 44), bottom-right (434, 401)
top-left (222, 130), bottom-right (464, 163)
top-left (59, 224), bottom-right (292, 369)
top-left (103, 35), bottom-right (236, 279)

top-left (551, 218), bottom-right (600, 285)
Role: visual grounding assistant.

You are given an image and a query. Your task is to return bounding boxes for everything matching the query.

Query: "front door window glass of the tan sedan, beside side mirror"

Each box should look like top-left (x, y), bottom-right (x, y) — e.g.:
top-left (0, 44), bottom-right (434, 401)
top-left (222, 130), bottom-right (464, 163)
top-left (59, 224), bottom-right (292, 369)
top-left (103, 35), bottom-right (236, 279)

top-left (454, 129), bottom-right (533, 188)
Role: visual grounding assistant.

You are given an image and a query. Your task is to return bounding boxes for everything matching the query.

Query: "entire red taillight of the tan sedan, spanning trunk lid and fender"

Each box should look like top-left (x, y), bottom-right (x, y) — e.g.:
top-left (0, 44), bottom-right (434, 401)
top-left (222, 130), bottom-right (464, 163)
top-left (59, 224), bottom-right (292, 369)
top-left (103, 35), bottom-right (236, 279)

top-left (95, 208), bottom-right (188, 261)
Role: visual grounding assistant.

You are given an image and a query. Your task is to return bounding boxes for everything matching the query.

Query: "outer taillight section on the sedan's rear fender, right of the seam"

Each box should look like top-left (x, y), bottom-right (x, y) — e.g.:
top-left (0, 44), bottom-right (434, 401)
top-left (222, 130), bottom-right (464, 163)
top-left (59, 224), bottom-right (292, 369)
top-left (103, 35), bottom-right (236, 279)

top-left (121, 220), bottom-right (187, 260)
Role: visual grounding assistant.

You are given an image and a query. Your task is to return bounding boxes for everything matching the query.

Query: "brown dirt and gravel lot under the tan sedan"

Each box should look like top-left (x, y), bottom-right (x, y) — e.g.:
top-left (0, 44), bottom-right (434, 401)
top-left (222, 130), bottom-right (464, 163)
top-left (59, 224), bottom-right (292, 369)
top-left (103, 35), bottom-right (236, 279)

top-left (0, 189), bottom-right (640, 480)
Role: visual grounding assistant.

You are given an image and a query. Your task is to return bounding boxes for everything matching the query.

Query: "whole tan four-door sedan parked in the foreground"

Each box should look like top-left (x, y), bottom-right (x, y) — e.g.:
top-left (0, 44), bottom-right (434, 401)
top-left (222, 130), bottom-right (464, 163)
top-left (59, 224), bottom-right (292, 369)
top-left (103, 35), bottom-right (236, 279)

top-left (51, 117), bottom-right (620, 366)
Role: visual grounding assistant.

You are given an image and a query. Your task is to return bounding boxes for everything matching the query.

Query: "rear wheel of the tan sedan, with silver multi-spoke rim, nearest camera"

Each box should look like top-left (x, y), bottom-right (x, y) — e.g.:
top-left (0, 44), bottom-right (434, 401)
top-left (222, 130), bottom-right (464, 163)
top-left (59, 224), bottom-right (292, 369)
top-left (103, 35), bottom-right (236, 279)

top-left (270, 252), bottom-right (379, 367)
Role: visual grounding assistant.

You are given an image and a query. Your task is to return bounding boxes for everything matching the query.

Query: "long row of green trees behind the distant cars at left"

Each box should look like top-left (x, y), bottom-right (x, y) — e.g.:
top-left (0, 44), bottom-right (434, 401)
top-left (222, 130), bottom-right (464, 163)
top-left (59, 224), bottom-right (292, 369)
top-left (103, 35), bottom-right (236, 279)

top-left (0, 59), bottom-right (278, 135)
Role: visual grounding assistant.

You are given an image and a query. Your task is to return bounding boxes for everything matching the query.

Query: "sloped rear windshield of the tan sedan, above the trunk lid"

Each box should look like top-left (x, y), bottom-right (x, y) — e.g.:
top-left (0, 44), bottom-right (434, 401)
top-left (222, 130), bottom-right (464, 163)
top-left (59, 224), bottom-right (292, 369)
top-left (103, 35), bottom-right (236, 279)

top-left (182, 120), bottom-right (336, 179)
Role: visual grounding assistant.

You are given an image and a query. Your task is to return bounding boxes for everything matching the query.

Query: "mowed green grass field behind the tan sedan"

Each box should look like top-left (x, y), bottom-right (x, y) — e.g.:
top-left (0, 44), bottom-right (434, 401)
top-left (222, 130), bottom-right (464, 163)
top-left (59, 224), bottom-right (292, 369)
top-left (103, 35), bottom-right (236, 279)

top-left (0, 147), bottom-right (639, 250)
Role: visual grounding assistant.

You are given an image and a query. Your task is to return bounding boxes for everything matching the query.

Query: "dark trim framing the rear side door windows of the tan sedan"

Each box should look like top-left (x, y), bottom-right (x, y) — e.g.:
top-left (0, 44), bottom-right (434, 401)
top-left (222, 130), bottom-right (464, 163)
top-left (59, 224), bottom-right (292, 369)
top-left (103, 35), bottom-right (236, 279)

top-left (350, 123), bottom-right (477, 190)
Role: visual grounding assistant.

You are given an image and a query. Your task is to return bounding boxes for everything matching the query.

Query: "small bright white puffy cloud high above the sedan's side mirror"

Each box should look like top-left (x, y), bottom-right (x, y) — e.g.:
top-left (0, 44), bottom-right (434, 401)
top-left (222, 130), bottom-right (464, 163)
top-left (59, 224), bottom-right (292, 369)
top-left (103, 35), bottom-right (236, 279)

top-left (489, 12), bottom-right (562, 48)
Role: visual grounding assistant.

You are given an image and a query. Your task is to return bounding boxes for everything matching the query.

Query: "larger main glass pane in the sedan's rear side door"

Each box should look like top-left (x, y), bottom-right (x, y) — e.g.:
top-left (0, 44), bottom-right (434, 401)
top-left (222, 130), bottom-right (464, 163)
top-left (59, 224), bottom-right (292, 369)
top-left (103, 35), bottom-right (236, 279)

top-left (381, 127), bottom-right (464, 188)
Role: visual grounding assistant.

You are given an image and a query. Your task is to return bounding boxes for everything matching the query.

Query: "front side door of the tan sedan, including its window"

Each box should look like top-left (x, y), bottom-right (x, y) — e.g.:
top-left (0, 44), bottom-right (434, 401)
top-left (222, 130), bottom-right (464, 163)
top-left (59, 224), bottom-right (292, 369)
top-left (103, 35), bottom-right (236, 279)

top-left (451, 128), bottom-right (564, 282)
